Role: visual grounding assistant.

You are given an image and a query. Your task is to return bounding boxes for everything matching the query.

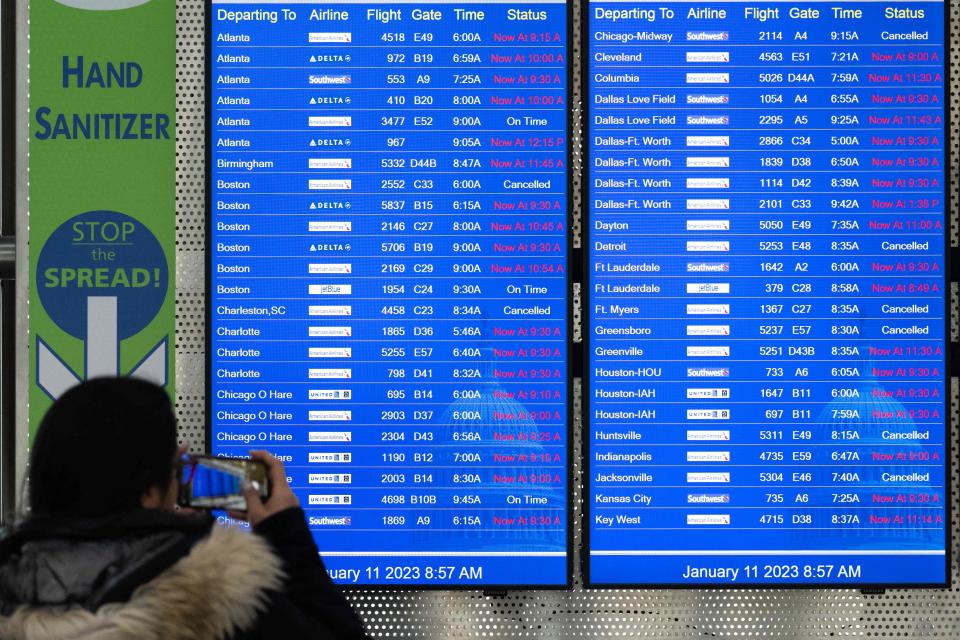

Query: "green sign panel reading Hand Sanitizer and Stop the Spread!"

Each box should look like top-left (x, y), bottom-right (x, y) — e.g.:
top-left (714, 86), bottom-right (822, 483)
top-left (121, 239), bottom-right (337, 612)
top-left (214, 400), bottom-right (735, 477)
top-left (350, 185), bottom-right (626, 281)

top-left (29, 0), bottom-right (176, 430)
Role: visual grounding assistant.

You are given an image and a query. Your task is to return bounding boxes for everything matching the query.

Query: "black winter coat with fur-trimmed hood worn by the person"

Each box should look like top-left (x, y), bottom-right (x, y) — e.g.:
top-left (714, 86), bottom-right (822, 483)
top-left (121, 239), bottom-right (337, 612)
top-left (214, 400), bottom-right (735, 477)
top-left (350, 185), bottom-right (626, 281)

top-left (0, 509), bottom-right (365, 640)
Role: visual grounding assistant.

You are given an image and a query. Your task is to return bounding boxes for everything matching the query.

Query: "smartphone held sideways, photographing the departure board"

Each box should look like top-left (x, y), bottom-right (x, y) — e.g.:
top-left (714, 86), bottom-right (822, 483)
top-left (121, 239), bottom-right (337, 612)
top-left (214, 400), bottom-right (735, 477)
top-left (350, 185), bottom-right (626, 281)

top-left (177, 454), bottom-right (270, 511)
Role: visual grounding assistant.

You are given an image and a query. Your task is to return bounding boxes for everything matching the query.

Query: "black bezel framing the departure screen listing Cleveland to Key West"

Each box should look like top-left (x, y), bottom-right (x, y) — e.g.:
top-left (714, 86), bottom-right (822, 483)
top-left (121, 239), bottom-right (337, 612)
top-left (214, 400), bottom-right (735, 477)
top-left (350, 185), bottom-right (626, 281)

top-left (580, 0), bottom-right (960, 591)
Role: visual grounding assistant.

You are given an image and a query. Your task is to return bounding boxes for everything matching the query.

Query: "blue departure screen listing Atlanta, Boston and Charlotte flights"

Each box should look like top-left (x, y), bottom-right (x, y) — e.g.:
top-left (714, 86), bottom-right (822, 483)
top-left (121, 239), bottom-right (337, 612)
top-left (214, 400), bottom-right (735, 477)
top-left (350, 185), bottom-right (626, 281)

top-left (208, 0), bottom-right (570, 588)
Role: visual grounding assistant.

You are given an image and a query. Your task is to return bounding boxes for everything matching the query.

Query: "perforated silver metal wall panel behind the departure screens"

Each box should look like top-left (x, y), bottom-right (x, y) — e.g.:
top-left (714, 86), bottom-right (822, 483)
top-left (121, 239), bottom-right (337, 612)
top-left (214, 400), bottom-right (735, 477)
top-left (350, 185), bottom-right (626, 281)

top-left (176, 0), bottom-right (960, 640)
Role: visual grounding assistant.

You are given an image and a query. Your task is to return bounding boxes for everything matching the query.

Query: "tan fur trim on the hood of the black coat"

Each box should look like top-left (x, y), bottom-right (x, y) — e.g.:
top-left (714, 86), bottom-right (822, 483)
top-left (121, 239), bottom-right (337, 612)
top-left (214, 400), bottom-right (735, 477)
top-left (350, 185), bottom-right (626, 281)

top-left (0, 527), bottom-right (284, 640)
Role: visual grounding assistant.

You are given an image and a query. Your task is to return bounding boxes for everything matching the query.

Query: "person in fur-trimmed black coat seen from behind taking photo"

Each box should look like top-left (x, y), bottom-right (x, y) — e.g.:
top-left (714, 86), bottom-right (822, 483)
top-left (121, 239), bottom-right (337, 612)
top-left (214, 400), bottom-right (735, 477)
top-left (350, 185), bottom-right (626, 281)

top-left (0, 378), bottom-right (366, 640)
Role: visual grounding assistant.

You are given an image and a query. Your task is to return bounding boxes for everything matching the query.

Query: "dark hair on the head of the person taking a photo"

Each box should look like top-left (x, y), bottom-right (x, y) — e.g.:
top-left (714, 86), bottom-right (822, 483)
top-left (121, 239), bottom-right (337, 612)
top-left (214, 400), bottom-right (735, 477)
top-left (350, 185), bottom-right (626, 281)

top-left (29, 378), bottom-right (177, 518)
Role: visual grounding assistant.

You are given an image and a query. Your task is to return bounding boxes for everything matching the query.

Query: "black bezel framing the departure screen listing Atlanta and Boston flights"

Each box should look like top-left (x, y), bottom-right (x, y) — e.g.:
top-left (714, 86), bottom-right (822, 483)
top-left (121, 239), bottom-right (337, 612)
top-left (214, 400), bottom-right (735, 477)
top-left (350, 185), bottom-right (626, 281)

top-left (203, 0), bottom-right (579, 592)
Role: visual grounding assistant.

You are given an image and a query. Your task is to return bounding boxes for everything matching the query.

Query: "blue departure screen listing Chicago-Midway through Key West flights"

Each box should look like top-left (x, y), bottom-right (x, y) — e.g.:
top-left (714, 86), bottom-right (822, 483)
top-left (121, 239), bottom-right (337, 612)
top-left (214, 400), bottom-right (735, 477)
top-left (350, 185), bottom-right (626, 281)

top-left (584, 0), bottom-right (949, 586)
